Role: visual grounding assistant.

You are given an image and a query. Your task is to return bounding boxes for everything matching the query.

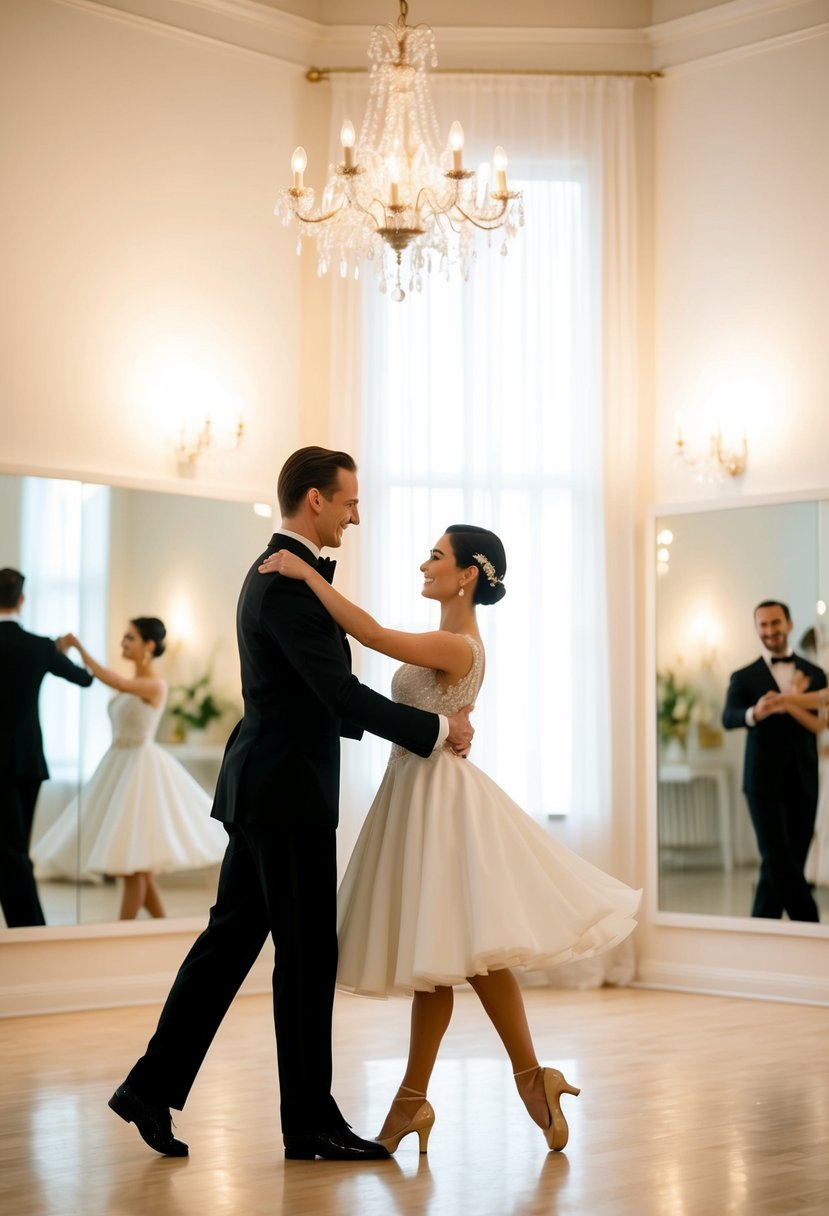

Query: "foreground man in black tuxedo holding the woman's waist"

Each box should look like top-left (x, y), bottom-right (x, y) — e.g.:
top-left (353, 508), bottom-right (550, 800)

top-left (109, 447), bottom-right (472, 1160)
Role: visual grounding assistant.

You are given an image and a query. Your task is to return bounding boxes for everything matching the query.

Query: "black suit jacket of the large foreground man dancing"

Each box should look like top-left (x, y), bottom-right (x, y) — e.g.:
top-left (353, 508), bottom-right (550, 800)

top-left (213, 533), bottom-right (439, 827)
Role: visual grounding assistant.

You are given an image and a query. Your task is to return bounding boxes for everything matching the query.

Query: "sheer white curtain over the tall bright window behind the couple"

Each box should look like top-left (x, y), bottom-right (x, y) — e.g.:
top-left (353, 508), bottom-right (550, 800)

top-left (332, 77), bottom-right (635, 982)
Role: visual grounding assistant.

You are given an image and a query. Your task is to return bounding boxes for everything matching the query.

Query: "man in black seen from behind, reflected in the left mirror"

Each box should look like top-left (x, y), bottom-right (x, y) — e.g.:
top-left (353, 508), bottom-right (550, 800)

top-left (0, 568), bottom-right (92, 929)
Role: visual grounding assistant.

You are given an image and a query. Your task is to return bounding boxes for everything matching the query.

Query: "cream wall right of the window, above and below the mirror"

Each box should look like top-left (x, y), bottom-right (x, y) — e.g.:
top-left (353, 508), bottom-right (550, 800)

top-left (638, 27), bottom-right (829, 1001)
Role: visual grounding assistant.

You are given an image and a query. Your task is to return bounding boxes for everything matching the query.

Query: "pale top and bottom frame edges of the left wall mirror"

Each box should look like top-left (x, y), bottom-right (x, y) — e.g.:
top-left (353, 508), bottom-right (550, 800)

top-left (0, 461), bottom-right (276, 946)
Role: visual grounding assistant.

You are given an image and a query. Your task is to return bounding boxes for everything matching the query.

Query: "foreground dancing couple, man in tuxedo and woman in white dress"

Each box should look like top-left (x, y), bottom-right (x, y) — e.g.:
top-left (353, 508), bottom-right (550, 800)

top-left (109, 447), bottom-right (641, 1161)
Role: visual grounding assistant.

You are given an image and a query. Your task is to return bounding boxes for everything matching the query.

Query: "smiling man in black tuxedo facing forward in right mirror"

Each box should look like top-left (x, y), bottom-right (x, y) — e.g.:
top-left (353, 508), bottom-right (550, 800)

top-left (722, 599), bottom-right (827, 921)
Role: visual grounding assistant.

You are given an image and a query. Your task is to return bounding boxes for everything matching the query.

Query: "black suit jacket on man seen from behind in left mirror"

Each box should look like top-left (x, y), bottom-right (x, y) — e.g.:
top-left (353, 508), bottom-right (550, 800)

top-left (0, 620), bottom-right (92, 781)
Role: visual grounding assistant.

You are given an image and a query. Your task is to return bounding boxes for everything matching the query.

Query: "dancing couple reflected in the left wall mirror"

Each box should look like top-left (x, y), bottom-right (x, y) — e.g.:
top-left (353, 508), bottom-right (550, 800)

top-left (0, 567), bottom-right (227, 929)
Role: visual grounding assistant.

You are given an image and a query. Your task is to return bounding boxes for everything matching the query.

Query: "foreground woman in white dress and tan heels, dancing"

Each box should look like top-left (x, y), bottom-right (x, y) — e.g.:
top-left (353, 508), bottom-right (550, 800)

top-left (260, 525), bottom-right (641, 1153)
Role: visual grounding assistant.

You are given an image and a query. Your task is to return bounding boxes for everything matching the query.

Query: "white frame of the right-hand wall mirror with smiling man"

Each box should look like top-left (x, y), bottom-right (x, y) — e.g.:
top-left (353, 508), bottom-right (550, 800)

top-left (643, 488), bottom-right (829, 938)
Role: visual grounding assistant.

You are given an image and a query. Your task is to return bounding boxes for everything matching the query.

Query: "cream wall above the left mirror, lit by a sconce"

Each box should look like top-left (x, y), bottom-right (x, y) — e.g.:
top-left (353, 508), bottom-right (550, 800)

top-left (0, 0), bottom-right (309, 496)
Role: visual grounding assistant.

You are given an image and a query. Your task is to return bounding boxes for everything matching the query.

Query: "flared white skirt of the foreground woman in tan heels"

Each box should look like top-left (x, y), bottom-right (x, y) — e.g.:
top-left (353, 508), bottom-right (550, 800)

top-left (337, 750), bottom-right (641, 996)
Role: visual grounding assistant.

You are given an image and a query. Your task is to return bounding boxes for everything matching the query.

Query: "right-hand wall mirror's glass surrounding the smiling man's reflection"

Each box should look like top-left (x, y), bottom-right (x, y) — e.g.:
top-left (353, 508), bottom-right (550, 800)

top-left (653, 499), bottom-right (829, 931)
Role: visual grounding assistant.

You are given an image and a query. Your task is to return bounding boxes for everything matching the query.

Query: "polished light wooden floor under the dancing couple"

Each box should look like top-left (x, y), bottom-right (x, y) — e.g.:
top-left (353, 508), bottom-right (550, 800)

top-left (0, 989), bottom-right (829, 1216)
